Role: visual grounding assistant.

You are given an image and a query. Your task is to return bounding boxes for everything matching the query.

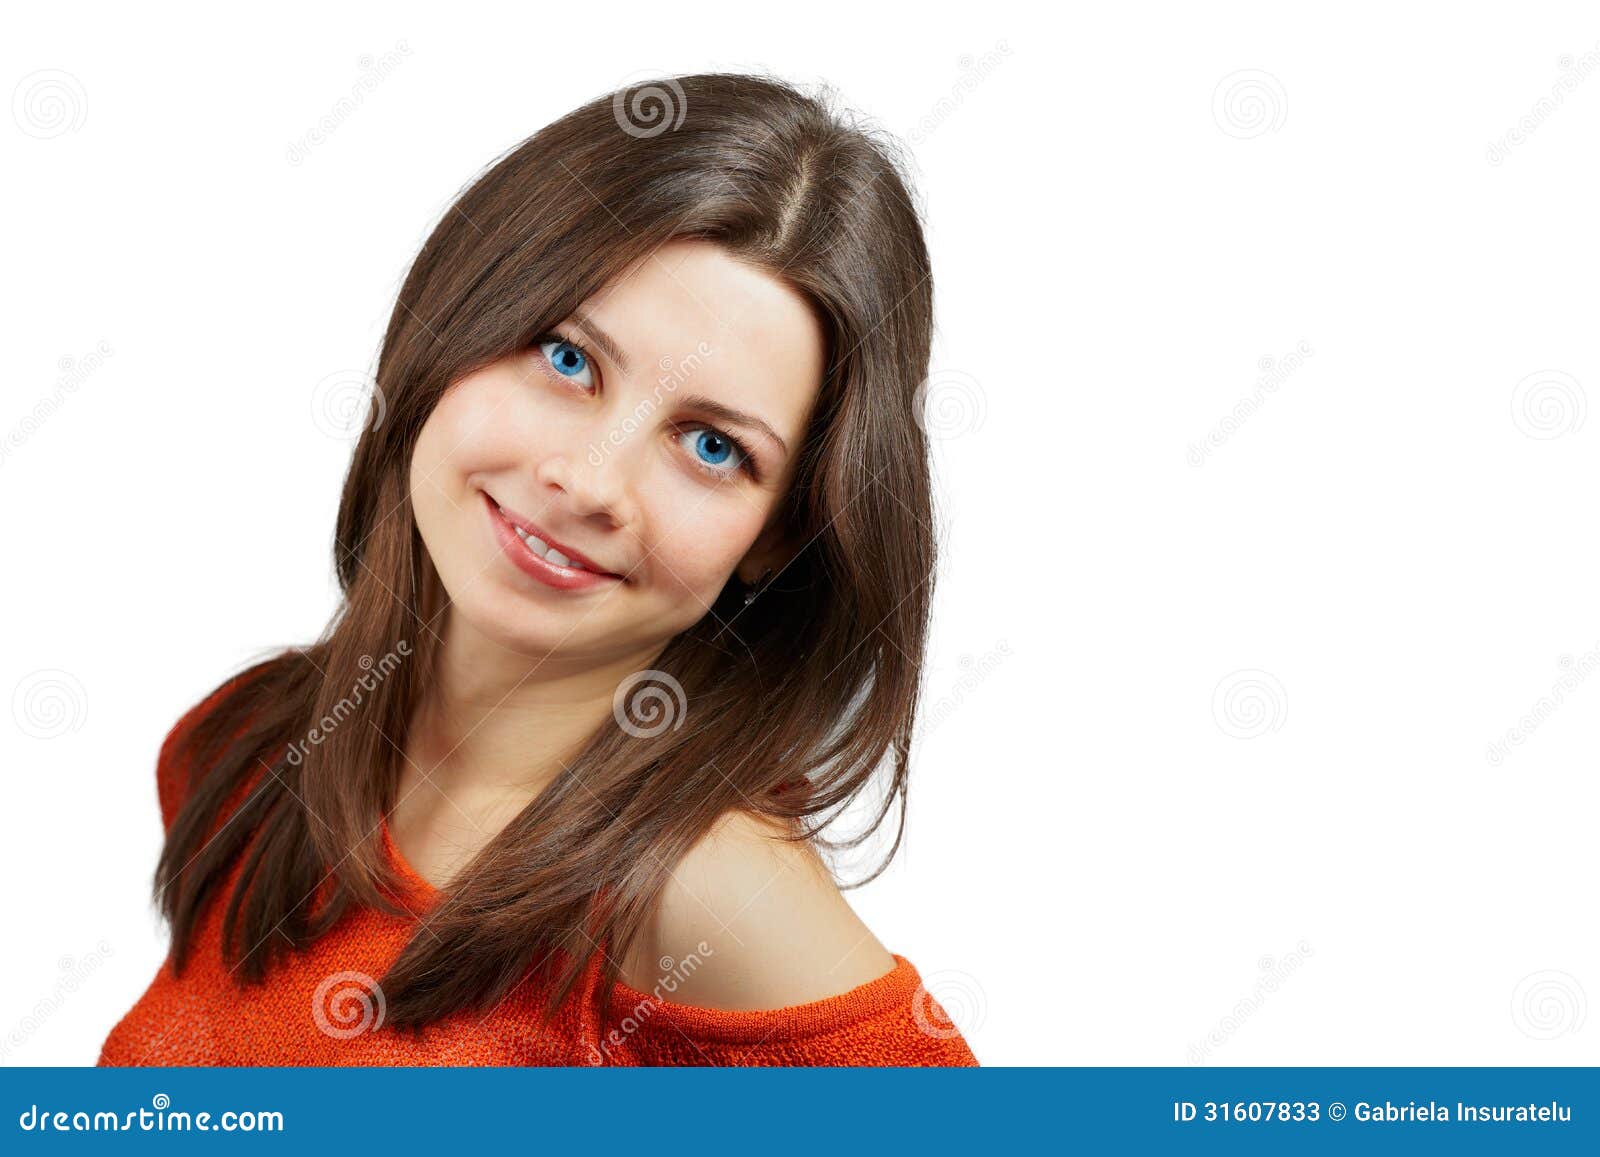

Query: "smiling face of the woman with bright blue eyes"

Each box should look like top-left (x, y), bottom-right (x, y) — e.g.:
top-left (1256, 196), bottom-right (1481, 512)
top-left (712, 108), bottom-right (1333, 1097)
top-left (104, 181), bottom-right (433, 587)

top-left (410, 240), bottom-right (824, 661)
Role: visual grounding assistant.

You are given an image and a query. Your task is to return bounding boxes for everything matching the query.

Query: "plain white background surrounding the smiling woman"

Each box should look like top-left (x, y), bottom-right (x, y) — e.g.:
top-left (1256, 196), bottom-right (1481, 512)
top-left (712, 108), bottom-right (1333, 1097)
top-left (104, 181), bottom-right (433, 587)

top-left (0, 3), bottom-right (1600, 1066)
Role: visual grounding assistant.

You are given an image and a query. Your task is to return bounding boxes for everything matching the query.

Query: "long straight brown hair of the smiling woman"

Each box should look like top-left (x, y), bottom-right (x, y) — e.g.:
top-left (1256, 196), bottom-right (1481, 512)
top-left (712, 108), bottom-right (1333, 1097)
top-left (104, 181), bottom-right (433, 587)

top-left (155, 74), bottom-right (934, 1031)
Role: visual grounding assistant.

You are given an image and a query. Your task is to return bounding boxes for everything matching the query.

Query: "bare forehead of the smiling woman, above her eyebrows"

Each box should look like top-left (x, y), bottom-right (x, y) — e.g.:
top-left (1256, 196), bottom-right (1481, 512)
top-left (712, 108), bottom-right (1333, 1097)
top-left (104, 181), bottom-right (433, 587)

top-left (582, 240), bottom-right (824, 451)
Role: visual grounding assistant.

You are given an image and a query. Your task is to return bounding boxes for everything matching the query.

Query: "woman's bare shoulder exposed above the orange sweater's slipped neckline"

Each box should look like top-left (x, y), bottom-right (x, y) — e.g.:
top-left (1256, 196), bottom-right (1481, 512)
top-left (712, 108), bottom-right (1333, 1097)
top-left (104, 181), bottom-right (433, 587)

top-left (621, 813), bottom-right (894, 1010)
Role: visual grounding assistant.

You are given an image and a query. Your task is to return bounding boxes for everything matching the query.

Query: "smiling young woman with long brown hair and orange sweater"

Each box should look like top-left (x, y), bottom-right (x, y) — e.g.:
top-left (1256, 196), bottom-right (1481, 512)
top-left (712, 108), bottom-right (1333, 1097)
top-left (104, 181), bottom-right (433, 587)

top-left (101, 74), bottom-right (976, 1066)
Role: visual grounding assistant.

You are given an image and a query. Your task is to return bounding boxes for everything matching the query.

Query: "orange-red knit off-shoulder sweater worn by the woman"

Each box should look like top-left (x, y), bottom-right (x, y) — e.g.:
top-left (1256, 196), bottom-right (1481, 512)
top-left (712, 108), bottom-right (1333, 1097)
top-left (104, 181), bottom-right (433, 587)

top-left (98, 685), bottom-right (978, 1066)
